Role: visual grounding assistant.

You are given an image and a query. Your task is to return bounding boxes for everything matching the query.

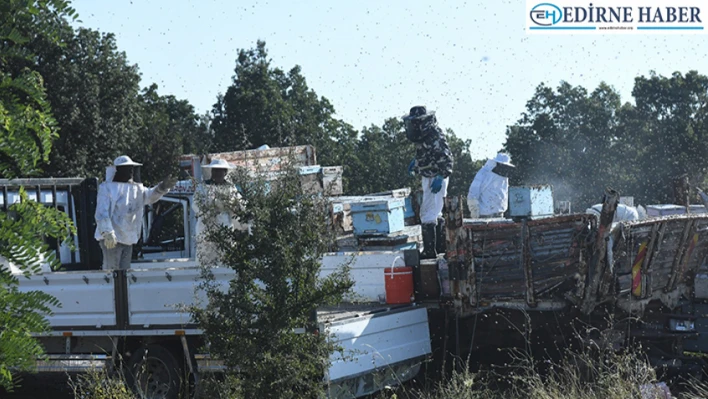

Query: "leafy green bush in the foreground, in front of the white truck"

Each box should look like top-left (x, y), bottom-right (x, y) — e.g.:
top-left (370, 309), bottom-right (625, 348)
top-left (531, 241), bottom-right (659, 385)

top-left (193, 164), bottom-right (353, 398)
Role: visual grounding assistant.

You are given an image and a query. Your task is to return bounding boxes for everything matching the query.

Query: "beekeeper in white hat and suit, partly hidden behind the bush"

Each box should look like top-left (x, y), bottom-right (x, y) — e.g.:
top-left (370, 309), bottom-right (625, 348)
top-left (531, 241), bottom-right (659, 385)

top-left (192, 159), bottom-right (249, 266)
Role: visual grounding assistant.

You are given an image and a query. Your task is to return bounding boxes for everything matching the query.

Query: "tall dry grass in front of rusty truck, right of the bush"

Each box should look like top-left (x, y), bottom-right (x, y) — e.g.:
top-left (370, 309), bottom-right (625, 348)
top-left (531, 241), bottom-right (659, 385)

top-left (379, 351), bottom-right (708, 399)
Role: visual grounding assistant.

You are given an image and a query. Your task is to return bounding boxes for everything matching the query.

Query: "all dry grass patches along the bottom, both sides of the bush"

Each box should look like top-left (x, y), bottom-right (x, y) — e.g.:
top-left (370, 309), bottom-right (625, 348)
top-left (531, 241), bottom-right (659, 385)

top-left (62, 350), bottom-right (708, 399)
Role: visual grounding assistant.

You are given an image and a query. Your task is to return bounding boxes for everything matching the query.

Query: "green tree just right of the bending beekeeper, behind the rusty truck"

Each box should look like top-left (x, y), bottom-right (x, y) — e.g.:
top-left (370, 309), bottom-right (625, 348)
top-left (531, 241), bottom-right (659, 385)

top-left (504, 82), bottom-right (628, 210)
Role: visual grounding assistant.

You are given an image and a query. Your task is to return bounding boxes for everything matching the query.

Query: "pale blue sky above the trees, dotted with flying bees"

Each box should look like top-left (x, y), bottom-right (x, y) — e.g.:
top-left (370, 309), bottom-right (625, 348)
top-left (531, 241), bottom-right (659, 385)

top-left (73, 0), bottom-right (708, 161)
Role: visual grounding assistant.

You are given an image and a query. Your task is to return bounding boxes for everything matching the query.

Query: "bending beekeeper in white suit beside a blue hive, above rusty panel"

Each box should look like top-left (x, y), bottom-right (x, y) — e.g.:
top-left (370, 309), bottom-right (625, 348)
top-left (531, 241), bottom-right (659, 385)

top-left (467, 153), bottom-right (515, 218)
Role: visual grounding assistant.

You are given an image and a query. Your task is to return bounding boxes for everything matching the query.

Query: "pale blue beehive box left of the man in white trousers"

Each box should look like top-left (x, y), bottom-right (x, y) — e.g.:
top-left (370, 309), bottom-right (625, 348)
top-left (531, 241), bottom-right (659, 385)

top-left (351, 198), bottom-right (405, 236)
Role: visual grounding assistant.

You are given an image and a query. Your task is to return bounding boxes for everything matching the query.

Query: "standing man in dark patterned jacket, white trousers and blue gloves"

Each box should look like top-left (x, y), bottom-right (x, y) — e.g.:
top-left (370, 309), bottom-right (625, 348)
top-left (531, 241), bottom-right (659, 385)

top-left (403, 106), bottom-right (453, 258)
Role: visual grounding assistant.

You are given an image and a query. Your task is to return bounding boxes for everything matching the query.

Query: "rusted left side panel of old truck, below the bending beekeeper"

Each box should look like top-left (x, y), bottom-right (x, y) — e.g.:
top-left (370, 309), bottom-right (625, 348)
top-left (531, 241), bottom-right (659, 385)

top-left (454, 214), bottom-right (594, 307)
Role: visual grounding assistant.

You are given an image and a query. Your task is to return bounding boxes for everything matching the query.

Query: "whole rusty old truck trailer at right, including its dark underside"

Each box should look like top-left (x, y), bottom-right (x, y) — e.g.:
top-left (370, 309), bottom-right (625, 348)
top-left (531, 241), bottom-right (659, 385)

top-left (429, 191), bottom-right (708, 378)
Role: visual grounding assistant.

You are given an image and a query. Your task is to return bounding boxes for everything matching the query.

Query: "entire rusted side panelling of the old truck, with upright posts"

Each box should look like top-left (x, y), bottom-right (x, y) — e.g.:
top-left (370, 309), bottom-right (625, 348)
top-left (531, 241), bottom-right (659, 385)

top-left (447, 190), bottom-right (708, 314)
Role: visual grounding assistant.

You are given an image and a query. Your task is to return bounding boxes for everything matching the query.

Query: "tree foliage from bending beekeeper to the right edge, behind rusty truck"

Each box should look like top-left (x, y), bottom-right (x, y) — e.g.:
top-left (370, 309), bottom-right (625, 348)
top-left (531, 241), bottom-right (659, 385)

top-left (505, 71), bottom-right (708, 211)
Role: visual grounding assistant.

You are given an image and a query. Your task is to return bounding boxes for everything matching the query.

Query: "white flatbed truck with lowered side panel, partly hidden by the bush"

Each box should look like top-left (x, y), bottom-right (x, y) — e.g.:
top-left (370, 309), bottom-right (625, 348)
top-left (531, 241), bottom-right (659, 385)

top-left (0, 179), bottom-right (431, 398)
